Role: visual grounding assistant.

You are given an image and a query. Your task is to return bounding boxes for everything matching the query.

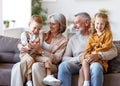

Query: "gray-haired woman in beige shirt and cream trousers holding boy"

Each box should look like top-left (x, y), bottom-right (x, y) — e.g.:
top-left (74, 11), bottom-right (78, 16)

top-left (11, 13), bottom-right (67, 86)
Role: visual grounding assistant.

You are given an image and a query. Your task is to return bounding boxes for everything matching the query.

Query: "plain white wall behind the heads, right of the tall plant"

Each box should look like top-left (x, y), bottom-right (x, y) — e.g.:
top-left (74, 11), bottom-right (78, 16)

top-left (43, 0), bottom-right (120, 40)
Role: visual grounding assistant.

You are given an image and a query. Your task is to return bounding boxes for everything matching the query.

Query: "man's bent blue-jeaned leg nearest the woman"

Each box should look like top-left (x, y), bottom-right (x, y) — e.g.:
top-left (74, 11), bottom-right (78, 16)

top-left (58, 62), bottom-right (80, 86)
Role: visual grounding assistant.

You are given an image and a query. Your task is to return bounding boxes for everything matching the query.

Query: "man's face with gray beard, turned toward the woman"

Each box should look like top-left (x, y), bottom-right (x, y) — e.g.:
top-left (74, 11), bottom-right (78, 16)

top-left (74, 16), bottom-right (84, 33)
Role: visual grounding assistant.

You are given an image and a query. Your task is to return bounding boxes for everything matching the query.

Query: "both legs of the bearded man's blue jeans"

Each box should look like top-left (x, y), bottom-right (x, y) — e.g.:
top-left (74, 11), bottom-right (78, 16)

top-left (58, 62), bottom-right (104, 86)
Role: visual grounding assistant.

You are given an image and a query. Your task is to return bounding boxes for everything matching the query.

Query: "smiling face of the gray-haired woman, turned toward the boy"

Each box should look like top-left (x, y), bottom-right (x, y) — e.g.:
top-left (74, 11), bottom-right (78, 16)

top-left (49, 17), bottom-right (60, 33)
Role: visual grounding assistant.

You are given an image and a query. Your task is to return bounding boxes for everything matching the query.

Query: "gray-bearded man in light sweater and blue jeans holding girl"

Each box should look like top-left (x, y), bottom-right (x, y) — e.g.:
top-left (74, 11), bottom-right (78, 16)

top-left (58, 12), bottom-right (117, 86)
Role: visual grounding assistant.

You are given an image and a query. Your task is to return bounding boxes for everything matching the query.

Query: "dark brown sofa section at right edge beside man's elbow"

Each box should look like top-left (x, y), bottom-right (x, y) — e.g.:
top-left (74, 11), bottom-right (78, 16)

top-left (108, 41), bottom-right (120, 73)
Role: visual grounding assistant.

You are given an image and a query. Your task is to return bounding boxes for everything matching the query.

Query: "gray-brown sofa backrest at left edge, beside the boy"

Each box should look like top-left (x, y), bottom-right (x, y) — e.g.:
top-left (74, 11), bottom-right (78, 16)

top-left (0, 36), bottom-right (20, 63)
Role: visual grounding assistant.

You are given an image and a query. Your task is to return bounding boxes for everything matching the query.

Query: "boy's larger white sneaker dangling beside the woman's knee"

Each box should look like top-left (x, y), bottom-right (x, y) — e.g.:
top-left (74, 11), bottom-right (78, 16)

top-left (43, 75), bottom-right (61, 86)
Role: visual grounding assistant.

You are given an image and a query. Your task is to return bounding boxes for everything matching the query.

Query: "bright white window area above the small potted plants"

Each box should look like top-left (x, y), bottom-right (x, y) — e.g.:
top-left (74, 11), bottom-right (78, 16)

top-left (2, 0), bottom-right (31, 28)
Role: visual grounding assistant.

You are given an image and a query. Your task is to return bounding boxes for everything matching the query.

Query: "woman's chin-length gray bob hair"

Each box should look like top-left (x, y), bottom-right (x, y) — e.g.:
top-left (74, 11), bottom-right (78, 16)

top-left (50, 13), bottom-right (66, 33)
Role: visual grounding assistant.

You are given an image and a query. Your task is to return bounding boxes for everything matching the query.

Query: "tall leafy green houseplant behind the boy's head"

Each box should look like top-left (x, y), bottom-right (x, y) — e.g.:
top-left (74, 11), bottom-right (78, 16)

top-left (32, 0), bottom-right (47, 24)
